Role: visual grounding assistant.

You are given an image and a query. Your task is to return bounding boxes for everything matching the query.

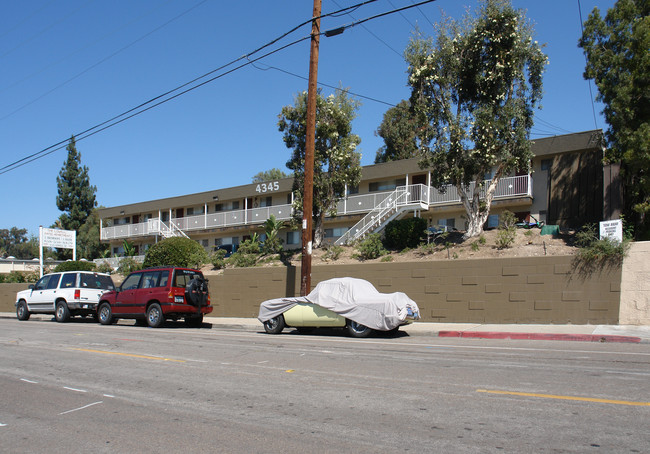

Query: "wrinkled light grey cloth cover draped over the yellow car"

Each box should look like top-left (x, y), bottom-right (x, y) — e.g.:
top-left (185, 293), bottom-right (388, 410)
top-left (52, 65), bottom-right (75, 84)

top-left (257, 277), bottom-right (420, 331)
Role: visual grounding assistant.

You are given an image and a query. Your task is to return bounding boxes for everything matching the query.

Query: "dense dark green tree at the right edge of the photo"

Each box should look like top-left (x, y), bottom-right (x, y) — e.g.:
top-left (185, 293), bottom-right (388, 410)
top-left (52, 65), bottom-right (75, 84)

top-left (578, 0), bottom-right (650, 238)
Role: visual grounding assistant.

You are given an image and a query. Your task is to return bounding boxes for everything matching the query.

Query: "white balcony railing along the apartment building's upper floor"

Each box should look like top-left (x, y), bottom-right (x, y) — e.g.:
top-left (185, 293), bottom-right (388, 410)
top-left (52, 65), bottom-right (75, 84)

top-left (101, 175), bottom-right (532, 240)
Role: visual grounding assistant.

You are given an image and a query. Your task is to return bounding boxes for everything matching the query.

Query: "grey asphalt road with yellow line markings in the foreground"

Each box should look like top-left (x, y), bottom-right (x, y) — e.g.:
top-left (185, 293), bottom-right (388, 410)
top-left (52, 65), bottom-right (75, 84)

top-left (0, 319), bottom-right (650, 453)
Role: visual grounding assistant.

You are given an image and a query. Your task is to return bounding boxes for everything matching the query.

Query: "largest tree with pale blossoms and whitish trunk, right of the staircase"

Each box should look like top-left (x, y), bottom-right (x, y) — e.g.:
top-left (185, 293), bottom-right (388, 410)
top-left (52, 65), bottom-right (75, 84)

top-left (405, 0), bottom-right (547, 238)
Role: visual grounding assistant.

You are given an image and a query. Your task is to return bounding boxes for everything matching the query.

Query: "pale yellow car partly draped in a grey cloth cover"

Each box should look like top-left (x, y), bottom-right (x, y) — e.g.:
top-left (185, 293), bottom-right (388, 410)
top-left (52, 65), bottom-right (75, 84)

top-left (258, 277), bottom-right (420, 337)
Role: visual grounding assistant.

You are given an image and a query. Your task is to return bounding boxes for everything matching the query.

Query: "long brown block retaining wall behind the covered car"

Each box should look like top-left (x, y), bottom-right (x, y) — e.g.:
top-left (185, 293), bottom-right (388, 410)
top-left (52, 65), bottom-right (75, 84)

top-left (207, 257), bottom-right (621, 324)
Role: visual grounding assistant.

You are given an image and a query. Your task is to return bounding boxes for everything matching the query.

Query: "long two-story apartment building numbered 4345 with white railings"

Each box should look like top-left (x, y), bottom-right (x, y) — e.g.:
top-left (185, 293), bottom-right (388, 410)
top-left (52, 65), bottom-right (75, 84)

top-left (99, 130), bottom-right (621, 256)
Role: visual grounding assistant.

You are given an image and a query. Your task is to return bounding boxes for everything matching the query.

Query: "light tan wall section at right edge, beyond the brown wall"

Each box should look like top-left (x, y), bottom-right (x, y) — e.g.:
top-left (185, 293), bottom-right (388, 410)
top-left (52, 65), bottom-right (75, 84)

top-left (619, 241), bottom-right (650, 325)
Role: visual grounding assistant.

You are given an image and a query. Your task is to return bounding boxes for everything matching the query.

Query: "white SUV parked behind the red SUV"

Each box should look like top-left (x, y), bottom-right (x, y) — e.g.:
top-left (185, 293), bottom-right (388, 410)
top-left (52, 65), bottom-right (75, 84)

top-left (16, 271), bottom-right (115, 323)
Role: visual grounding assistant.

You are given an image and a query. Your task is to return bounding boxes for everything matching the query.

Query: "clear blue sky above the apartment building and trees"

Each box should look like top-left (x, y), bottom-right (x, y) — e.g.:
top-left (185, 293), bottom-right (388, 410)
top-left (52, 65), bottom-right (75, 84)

top-left (0, 0), bottom-right (614, 238)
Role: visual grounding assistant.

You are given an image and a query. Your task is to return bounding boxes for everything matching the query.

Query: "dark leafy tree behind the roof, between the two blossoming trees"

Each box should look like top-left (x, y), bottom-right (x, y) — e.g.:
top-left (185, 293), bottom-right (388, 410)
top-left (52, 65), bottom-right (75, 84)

top-left (375, 100), bottom-right (419, 164)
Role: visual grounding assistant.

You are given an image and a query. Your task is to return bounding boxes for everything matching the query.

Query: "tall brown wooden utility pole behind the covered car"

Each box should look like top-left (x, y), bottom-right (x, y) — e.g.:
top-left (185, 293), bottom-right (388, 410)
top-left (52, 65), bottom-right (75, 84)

top-left (300, 0), bottom-right (321, 296)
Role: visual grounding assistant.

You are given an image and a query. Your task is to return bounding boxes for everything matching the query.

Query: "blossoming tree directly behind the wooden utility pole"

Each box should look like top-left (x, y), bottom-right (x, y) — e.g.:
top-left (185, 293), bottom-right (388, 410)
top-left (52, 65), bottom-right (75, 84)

top-left (278, 89), bottom-right (361, 247)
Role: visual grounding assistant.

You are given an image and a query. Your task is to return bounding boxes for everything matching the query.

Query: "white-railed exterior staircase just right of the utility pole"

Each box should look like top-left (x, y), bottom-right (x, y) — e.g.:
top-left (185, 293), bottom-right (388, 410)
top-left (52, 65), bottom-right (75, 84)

top-left (334, 184), bottom-right (429, 245)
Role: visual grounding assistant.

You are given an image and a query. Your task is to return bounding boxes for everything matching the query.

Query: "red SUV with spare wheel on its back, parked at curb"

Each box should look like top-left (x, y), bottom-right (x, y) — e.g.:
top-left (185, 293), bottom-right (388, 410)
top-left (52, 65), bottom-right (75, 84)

top-left (97, 267), bottom-right (212, 328)
